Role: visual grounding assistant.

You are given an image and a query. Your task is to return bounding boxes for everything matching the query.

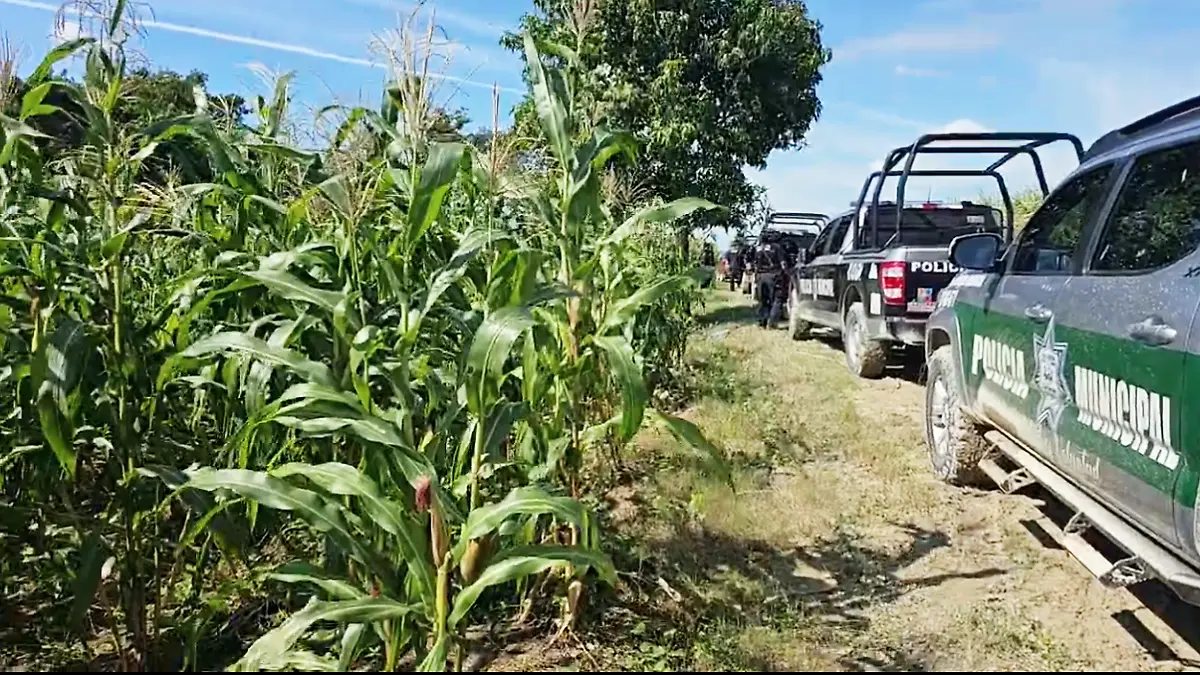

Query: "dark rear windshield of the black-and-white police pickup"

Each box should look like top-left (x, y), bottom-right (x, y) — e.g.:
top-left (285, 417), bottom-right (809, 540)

top-left (862, 205), bottom-right (1002, 249)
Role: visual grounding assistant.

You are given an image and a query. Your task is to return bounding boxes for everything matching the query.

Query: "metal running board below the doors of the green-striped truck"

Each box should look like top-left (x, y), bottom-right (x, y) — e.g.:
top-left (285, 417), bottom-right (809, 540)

top-left (980, 430), bottom-right (1200, 605)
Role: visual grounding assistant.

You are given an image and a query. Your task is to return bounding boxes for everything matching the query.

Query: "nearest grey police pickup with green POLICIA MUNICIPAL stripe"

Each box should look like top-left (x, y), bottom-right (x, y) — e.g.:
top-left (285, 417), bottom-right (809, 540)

top-left (925, 97), bottom-right (1200, 604)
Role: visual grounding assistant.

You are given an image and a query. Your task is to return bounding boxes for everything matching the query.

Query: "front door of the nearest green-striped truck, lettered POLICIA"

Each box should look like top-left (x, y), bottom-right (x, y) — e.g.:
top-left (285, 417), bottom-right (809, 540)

top-left (956, 166), bottom-right (1112, 454)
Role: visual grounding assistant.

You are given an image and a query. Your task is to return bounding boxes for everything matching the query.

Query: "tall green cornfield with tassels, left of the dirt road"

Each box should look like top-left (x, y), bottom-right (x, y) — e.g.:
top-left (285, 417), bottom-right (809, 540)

top-left (0, 1), bottom-right (725, 671)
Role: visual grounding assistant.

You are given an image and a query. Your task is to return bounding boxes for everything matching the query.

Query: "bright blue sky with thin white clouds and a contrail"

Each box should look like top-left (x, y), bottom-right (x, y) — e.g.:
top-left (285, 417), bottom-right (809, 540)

top-left (0, 0), bottom-right (1200, 246)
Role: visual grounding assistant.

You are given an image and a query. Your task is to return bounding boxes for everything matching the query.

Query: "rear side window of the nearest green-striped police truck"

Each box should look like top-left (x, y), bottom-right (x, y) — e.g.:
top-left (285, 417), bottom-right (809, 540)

top-left (1092, 138), bottom-right (1200, 273)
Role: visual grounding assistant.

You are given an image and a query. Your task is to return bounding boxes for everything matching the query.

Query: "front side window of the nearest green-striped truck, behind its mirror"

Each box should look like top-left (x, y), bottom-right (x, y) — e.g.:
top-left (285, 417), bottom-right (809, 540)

top-left (1009, 165), bottom-right (1112, 275)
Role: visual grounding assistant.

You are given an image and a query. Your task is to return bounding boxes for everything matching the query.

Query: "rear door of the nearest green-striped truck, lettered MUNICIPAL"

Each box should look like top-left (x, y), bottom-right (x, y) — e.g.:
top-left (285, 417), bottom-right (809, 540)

top-left (1055, 142), bottom-right (1200, 543)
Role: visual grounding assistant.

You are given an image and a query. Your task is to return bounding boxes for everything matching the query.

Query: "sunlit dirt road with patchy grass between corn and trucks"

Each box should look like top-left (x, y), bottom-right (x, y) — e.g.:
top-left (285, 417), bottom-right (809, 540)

top-left (614, 292), bottom-right (1196, 671)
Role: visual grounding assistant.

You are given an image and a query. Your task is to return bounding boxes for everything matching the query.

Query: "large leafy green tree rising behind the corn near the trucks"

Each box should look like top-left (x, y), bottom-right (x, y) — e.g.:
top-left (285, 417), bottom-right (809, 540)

top-left (502, 0), bottom-right (830, 240)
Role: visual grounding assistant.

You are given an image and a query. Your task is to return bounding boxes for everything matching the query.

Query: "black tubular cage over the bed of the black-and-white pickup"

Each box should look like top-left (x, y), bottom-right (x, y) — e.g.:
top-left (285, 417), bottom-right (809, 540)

top-left (854, 131), bottom-right (1084, 247)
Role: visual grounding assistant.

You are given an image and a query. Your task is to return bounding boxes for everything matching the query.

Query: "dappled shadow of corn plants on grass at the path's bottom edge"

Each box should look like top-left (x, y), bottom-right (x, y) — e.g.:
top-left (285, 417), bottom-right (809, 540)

top-left (578, 511), bottom-right (1004, 671)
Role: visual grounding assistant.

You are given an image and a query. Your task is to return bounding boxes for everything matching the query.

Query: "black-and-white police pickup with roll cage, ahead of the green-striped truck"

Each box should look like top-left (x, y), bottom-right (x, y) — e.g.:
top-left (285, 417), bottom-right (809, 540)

top-left (787, 132), bottom-right (1082, 377)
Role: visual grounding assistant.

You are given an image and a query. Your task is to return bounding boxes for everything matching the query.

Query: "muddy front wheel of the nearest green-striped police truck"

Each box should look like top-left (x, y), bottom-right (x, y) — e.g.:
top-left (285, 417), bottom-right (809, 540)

top-left (924, 346), bottom-right (990, 485)
